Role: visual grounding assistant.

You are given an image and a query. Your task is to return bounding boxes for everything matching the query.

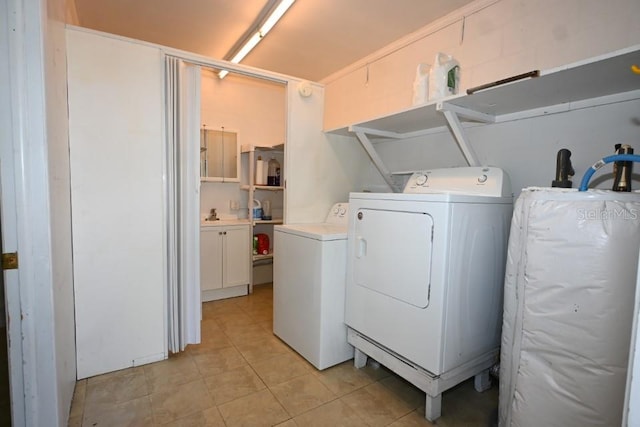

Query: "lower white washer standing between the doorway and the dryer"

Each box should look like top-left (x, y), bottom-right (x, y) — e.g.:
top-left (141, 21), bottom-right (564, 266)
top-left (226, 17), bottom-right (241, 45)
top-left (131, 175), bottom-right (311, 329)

top-left (273, 203), bottom-right (353, 369)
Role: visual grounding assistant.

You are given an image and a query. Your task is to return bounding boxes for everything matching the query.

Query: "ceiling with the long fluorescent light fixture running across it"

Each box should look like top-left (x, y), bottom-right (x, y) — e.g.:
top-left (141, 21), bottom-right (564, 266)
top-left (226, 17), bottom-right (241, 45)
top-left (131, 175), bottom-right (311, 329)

top-left (75, 0), bottom-right (472, 81)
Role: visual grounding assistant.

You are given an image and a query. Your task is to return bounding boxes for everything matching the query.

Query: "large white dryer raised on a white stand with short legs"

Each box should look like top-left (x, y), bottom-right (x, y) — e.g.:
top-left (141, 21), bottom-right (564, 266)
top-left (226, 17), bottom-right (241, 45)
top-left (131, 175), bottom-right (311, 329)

top-left (345, 167), bottom-right (513, 420)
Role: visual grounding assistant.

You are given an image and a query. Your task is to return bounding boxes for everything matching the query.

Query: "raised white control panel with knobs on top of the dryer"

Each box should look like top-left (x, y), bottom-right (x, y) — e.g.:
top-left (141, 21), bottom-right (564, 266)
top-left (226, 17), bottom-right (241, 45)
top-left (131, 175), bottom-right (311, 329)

top-left (403, 166), bottom-right (511, 197)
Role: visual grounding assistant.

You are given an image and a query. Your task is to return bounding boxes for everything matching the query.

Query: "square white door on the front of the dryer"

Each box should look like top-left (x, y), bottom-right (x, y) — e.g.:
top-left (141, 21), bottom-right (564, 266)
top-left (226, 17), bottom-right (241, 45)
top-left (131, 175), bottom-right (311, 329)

top-left (353, 209), bottom-right (433, 308)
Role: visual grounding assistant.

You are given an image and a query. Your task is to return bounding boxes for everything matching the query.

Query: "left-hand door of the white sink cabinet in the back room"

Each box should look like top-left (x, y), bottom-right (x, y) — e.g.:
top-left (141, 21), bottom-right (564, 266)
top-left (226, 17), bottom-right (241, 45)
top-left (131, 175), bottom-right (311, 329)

top-left (200, 227), bottom-right (224, 291)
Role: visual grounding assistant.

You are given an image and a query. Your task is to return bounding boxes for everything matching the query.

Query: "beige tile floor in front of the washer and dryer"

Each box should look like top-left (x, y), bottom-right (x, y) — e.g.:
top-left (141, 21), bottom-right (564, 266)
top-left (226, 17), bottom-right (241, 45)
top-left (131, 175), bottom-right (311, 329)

top-left (69, 285), bottom-right (498, 427)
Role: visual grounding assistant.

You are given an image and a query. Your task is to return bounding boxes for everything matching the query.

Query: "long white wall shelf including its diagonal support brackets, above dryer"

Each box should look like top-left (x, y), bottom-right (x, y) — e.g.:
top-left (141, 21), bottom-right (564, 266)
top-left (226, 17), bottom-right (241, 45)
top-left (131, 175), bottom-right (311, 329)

top-left (325, 45), bottom-right (640, 191)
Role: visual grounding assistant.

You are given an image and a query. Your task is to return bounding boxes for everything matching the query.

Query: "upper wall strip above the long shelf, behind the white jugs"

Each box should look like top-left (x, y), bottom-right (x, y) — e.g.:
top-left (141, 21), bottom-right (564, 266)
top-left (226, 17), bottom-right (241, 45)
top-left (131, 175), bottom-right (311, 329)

top-left (324, 0), bottom-right (640, 129)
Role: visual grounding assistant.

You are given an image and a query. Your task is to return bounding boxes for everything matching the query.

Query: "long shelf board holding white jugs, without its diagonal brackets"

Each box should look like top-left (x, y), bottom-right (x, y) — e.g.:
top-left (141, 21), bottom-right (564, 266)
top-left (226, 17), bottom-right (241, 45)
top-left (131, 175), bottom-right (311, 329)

top-left (326, 45), bottom-right (640, 138)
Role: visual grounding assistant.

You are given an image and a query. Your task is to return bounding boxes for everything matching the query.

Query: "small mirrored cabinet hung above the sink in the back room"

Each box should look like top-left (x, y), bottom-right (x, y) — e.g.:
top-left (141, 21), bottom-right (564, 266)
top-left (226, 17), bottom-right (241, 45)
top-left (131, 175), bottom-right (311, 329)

top-left (200, 127), bottom-right (240, 182)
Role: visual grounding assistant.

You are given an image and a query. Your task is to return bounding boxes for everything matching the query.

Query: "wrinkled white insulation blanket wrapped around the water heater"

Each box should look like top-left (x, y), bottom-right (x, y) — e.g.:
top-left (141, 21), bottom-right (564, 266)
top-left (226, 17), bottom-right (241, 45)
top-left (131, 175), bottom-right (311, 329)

top-left (500, 188), bottom-right (640, 427)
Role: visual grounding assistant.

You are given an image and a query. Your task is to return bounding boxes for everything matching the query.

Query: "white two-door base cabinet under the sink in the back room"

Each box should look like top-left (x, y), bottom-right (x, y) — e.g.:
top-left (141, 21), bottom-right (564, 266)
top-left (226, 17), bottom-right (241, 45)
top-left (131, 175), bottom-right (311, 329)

top-left (200, 223), bottom-right (251, 301)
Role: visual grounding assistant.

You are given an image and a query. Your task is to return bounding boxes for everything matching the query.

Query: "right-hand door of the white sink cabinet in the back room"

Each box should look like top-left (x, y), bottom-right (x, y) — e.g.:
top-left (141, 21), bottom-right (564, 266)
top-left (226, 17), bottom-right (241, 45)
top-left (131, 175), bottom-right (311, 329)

top-left (222, 225), bottom-right (251, 287)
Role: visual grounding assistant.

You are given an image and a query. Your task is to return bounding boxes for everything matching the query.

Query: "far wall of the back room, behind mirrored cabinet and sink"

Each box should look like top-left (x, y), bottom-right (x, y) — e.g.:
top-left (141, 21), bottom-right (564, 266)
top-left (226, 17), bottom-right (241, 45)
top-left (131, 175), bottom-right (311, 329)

top-left (200, 71), bottom-right (287, 218)
